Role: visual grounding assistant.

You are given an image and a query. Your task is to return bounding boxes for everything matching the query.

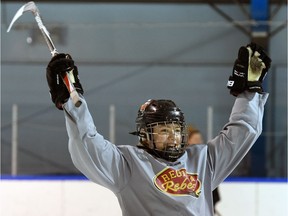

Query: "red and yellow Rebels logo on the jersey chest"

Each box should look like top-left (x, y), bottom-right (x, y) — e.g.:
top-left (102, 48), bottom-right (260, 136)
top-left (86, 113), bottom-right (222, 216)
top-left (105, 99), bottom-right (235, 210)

top-left (154, 168), bottom-right (201, 197)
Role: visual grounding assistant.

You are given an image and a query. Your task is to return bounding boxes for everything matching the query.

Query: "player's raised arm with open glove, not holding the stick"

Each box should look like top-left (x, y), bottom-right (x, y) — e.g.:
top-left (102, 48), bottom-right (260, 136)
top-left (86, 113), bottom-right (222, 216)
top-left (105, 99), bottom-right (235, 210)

top-left (208, 43), bottom-right (271, 187)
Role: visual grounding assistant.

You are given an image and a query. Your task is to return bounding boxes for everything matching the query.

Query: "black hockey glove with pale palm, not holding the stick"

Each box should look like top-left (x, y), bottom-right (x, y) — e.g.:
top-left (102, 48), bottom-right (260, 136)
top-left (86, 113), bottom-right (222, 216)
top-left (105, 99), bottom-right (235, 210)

top-left (227, 43), bottom-right (271, 96)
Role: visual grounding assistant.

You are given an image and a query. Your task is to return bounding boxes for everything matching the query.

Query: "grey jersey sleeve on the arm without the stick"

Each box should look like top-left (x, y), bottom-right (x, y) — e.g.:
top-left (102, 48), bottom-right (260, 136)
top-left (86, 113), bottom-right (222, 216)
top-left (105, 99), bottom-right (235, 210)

top-left (208, 92), bottom-right (268, 188)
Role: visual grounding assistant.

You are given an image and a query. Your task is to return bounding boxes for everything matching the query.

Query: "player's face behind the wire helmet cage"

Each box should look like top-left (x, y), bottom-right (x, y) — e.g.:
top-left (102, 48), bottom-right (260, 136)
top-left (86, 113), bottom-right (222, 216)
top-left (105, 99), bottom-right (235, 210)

top-left (153, 123), bottom-right (182, 150)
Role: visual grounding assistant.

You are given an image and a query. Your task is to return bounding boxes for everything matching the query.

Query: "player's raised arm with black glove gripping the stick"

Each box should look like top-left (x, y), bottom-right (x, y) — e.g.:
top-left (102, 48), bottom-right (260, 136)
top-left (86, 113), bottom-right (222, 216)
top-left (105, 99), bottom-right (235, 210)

top-left (46, 53), bottom-right (130, 192)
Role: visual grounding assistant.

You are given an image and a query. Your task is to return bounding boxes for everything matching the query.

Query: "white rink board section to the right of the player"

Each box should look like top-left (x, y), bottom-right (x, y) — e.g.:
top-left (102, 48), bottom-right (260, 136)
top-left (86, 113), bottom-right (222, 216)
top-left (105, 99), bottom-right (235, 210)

top-left (216, 182), bottom-right (288, 216)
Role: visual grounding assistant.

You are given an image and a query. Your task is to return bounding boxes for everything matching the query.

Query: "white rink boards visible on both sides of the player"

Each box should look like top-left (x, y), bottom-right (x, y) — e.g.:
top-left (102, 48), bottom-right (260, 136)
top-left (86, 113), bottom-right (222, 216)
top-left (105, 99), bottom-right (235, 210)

top-left (0, 177), bottom-right (288, 216)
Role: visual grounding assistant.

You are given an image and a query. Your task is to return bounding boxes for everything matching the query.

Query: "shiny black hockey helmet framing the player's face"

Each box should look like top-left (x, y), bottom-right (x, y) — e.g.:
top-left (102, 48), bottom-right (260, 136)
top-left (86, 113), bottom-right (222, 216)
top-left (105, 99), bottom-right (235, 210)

top-left (132, 99), bottom-right (186, 161)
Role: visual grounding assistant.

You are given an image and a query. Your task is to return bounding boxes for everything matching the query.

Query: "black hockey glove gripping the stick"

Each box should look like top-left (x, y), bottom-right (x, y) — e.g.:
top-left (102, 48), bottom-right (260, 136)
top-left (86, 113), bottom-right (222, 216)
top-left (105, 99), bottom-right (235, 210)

top-left (46, 53), bottom-right (84, 110)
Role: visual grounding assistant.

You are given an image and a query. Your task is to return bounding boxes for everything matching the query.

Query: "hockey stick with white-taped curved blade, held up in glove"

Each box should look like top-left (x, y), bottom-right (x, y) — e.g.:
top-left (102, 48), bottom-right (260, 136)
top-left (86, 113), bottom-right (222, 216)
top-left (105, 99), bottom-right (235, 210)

top-left (7, 1), bottom-right (82, 107)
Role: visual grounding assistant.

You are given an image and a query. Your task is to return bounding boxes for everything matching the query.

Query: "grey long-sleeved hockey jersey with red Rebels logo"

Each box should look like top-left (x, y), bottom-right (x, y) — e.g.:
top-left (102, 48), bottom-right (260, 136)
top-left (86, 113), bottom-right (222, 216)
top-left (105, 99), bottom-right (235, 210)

top-left (64, 92), bottom-right (268, 216)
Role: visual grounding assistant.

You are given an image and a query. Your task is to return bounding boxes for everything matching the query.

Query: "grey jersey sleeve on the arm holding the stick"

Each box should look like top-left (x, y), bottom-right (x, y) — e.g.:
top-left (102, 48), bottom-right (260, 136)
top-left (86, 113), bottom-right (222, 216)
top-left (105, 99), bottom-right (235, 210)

top-left (64, 97), bottom-right (131, 193)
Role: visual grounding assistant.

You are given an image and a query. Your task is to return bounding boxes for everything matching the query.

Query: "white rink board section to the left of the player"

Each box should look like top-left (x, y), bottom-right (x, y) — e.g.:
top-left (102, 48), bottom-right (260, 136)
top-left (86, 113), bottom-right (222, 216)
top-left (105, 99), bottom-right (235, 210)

top-left (0, 180), bottom-right (121, 216)
